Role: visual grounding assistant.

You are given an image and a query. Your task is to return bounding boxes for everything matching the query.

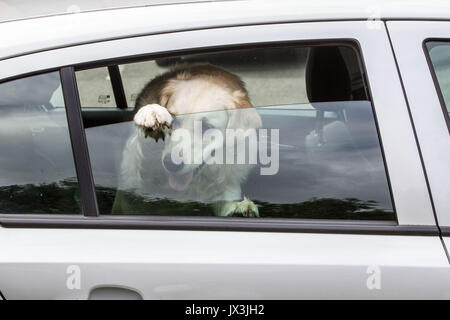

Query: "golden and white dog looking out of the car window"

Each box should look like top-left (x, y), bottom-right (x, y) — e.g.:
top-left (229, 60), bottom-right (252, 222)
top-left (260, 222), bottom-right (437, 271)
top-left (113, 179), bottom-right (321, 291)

top-left (112, 64), bottom-right (262, 217)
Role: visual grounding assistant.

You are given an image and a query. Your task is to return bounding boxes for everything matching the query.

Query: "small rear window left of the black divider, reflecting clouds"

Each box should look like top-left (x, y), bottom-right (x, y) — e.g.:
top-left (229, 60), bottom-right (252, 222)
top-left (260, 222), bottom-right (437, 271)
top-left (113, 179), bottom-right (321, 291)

top-left (0, 72), bottom-right (81, 214)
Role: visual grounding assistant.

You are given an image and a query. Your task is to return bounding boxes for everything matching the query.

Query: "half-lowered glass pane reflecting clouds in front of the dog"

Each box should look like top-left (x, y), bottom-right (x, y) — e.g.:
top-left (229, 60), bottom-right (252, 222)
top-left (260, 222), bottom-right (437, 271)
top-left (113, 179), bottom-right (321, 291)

top-left (86, 101), bottom-right (395, 220)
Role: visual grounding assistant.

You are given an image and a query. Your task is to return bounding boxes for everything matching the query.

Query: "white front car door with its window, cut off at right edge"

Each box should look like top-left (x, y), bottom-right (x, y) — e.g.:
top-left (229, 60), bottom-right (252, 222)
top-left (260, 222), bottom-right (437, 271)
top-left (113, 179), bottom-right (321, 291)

top-left (388, 21), bottom-right (450, 260)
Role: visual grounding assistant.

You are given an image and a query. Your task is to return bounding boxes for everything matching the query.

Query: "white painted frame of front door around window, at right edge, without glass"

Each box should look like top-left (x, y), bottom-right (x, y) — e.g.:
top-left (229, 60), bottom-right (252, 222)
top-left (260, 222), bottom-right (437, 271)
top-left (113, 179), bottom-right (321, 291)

top-left (387, 21), bottom-right (450, 227)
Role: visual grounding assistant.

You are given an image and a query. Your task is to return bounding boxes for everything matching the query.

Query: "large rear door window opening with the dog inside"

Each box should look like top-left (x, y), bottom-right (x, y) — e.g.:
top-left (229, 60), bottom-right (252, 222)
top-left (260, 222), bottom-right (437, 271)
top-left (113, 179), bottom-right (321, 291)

top-left (77, 45), bottom-right (395, 220)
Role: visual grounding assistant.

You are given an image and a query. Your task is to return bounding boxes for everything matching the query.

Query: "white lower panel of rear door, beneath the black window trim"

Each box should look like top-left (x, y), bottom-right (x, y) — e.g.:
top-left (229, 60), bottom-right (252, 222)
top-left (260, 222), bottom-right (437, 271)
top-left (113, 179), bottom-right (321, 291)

top-left (0, 229), bottom-right (450, 299)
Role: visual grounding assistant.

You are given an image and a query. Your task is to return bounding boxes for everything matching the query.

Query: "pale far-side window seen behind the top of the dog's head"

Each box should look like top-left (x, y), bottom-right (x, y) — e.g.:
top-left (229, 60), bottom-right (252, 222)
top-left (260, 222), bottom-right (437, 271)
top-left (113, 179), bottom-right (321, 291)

top-left (120, 48), bottom-right (308, 106)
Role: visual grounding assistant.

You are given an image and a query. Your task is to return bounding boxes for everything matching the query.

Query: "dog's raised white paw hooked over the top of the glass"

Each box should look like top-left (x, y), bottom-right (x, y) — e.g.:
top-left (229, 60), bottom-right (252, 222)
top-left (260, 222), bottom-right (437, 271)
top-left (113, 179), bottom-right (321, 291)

top-left (134, 104), bottom-right (173, 141)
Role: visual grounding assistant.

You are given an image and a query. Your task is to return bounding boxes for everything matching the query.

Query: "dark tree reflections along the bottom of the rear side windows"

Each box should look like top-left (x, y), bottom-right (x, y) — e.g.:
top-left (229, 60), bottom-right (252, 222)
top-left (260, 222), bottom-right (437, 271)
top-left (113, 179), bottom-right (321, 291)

top-left (0, 178), bottom-right (395, 220)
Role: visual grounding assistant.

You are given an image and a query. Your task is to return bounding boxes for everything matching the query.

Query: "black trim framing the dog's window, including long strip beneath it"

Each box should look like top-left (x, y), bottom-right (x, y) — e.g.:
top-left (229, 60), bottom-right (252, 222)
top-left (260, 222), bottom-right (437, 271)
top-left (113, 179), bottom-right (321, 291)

top-left (0, 22), bottom-right (438, 235)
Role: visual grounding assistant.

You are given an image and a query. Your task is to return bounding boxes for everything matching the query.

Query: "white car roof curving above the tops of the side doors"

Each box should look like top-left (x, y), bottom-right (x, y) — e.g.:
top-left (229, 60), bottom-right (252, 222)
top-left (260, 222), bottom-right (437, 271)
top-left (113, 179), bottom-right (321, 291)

top-left (0, 0), bottom-right (450, 60)
